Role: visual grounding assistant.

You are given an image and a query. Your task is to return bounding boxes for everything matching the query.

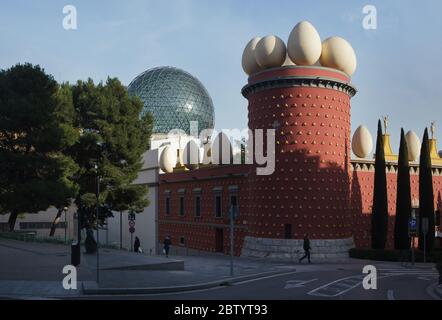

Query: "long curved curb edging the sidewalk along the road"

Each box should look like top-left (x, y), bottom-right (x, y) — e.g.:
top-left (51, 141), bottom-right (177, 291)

top-left (82, 269), bottom-right (296, 295)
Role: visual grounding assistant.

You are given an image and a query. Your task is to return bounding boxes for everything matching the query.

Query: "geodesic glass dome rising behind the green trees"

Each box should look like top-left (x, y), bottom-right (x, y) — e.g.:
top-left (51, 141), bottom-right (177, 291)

top-left (128, 67), bottom-right (214, 134)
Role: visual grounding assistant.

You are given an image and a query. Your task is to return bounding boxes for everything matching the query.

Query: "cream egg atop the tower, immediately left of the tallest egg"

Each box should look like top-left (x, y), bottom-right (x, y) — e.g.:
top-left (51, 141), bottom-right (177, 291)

top-left (255, 36), bottom-right (287, 69)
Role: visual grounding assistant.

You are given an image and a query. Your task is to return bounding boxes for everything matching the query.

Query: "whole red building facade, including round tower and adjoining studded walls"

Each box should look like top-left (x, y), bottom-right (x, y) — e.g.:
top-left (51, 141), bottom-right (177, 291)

top-left (158, 67), bottom-right (442, 255)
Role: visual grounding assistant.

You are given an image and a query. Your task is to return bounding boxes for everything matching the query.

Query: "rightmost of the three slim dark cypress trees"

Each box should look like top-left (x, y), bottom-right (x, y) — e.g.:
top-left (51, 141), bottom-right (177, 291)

top-left (419, 128), bottom-right (434, 251)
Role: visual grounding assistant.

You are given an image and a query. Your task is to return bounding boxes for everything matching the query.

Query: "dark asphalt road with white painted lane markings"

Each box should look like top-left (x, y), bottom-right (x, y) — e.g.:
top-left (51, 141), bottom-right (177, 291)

top-left (77, 265), bottom-right (438, 301)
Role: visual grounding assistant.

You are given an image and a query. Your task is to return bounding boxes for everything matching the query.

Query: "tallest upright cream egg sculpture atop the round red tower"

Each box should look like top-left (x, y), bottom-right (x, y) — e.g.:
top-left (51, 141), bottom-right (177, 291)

top-left (287, 21), bottom-right (322, 66)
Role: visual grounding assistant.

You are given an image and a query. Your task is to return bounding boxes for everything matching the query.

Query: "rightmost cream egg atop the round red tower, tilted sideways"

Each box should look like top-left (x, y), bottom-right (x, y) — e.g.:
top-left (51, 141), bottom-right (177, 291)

top-left (319, 37), bottom-right (357, 76)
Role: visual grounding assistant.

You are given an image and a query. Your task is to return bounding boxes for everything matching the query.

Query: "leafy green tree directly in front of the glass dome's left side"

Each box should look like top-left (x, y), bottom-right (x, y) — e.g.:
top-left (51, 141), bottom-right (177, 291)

top-left (70, 79), bottom-right (152, 251)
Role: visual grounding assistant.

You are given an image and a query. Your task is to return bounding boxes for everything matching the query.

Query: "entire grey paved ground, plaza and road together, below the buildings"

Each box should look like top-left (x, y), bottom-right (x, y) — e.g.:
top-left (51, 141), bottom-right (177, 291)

top-left (0, 239), bottom-right (440, 300)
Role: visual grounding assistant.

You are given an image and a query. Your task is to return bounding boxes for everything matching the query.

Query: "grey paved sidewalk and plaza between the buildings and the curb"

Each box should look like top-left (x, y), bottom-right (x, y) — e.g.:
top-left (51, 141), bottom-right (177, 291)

top-left (0, 239), bottom-right (436, 298)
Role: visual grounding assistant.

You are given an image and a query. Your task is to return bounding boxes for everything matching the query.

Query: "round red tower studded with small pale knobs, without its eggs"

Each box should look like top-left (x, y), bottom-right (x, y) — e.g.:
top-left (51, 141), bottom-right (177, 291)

top-left (242, 66), bottom-right (356, 239)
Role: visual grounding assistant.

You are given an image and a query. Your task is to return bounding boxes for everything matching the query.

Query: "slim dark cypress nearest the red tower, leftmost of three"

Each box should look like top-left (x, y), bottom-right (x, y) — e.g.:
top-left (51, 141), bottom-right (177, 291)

top-left (371, 120), bottom-right (388, 249)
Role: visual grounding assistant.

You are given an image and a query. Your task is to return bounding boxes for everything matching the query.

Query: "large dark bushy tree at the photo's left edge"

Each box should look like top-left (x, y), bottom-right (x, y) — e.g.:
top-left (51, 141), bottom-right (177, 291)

top-left (0, 64), bottom-right (78, 231)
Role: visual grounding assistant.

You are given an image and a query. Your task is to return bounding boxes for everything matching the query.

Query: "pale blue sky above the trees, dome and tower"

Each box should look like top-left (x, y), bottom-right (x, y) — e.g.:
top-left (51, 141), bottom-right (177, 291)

top-left (0, 0), bottom-right (442, 152)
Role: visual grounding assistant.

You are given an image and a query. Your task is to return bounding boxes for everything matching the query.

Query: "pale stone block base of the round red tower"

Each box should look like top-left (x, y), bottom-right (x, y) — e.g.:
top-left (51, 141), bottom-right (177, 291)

top-left (241, 237), bottom-right (355, 262)
